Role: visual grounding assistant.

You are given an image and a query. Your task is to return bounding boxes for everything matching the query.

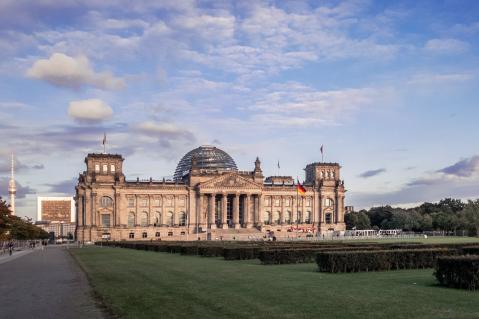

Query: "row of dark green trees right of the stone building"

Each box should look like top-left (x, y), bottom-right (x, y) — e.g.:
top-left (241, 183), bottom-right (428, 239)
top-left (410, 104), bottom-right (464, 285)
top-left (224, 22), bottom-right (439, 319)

top-left (345, 198), bottom-right (479, 236)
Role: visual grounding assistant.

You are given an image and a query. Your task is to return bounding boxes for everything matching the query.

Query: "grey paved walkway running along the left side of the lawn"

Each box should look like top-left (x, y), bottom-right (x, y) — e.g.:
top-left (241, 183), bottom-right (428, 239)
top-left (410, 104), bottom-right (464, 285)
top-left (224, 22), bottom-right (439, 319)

top-left (0, 246), bottom-right (104, 319)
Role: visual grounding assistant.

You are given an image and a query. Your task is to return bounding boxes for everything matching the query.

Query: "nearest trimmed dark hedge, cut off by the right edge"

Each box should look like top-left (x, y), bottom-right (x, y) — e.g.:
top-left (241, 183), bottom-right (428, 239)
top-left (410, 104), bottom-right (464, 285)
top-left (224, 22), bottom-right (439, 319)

top-left (434, 255), bottom-right (479, 290)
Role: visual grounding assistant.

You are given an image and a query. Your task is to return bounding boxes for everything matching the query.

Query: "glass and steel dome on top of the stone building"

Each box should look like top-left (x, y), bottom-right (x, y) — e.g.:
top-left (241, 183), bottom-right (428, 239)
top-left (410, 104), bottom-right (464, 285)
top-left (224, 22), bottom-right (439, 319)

top-left (173, 145), bottom-right (238, 180)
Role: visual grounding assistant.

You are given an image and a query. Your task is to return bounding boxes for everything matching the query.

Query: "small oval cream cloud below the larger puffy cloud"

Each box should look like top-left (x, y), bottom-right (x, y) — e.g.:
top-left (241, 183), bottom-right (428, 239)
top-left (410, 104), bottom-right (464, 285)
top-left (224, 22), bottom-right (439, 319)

top-left (68, 99), bottom-right (113, 122)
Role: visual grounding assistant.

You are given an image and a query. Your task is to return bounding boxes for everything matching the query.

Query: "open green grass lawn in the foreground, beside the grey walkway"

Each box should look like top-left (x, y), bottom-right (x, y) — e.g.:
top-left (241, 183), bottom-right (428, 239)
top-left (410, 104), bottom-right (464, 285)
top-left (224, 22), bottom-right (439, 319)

top-left (71, 247), bottom-right (479, 318)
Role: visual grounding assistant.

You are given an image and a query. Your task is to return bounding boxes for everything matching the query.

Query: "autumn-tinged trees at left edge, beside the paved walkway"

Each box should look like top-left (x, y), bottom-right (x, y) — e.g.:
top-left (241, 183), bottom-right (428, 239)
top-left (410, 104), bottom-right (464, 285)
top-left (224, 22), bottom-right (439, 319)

top-left (0, 197), bottom-right (49, 241)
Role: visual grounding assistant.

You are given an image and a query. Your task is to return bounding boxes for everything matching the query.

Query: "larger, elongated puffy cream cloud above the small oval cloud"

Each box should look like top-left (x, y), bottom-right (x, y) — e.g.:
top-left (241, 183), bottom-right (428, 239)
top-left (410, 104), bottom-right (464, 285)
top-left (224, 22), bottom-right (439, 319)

top-left (27, 53), bottom-right (125, 90)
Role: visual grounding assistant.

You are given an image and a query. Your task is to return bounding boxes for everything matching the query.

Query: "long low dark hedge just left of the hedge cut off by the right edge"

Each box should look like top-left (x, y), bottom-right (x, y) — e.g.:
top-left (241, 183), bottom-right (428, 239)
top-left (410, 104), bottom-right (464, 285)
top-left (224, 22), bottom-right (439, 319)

top-left (316, 248), bottom-right (457, 273)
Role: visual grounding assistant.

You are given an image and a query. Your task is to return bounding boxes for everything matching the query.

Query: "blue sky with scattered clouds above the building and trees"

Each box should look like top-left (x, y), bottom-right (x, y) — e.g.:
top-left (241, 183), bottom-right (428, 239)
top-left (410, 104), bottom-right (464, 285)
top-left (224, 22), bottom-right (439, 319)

top-left (0, 0), bottom-right (479, 221)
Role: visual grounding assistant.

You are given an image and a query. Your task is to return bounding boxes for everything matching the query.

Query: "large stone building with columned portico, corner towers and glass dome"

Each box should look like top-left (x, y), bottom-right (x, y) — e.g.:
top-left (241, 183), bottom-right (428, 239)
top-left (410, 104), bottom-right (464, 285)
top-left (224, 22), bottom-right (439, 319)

top-left (75, 146), bottom-right (345, 241)
